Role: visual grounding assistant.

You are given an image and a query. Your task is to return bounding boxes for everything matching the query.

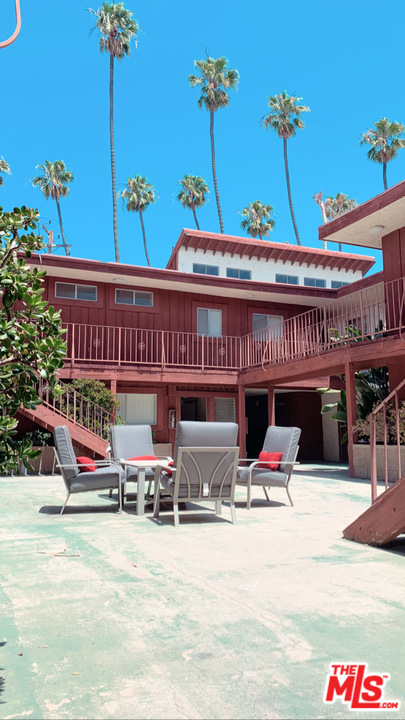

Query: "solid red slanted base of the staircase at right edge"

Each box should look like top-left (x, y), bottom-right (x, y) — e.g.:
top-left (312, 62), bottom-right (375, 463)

top-left (343, 475), bottom-right (405, 545)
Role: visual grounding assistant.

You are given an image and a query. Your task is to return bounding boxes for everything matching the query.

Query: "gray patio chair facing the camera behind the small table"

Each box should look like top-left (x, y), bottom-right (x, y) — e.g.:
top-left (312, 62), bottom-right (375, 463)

top-left (110, 425), bottom-right (163, 505)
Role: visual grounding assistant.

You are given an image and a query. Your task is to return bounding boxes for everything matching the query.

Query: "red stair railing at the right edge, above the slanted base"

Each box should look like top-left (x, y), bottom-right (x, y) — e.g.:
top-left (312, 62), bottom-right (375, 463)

top-left (370, 380), bottom-right (405, 503)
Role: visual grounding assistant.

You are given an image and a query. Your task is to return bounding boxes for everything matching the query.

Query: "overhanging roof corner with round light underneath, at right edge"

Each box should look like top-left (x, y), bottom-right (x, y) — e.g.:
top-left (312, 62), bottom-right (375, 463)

top-left (319, 180), bottom-right (405, 250)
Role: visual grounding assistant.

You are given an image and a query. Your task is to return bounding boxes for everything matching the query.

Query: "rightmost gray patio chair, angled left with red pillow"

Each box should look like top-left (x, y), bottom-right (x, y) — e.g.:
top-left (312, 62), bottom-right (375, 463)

top-left (236, 425), bottom-right (301, 510)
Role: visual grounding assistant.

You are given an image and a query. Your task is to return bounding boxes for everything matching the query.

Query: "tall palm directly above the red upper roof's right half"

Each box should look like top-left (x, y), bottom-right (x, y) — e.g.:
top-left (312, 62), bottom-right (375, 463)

top-left (263, 90), bottom-right (309, 245)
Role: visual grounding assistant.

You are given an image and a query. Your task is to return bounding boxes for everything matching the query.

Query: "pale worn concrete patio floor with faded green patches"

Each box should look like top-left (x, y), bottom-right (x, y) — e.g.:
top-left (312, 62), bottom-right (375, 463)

top-left (0, 465), bottom-right (405, 720)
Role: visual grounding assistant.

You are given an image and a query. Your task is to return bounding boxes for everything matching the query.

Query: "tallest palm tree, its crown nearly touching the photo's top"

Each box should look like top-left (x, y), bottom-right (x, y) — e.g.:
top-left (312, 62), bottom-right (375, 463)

top-left (90, 2), bottom-right (139, 262)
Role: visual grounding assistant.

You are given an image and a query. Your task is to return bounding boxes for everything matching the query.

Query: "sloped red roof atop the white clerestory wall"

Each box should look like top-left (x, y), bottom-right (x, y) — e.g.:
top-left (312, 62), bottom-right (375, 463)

top-left (166, 228), bottom-right (375, 275)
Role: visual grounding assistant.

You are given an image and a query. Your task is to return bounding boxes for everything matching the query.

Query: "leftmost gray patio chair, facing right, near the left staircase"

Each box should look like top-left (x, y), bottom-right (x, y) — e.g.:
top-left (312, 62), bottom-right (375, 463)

top-left (54, 425), bottom-right (122, 515)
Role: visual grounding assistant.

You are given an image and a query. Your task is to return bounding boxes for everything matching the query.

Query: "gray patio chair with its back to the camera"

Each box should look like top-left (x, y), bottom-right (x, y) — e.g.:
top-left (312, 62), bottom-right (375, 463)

top-left (153, 421), bottom-right (239, 527)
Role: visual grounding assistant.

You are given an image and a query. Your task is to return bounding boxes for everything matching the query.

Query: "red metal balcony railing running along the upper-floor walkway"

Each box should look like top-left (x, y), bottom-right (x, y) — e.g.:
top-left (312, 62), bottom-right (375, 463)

top-left (60, 278), bottom-right (404, 371)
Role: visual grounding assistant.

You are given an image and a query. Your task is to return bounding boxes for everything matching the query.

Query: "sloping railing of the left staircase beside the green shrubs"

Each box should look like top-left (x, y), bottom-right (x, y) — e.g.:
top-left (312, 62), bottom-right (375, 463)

top-left (38, 381), bottom-right (115, 440)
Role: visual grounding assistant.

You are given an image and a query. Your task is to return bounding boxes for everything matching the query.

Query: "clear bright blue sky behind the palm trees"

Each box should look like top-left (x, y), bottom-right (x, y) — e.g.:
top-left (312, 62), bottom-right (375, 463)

top-left (0, 0), bottom-right (405, 269)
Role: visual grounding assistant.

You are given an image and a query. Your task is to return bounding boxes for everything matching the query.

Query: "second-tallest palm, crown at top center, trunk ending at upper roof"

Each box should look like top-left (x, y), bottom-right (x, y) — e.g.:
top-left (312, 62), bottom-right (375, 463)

top-left (188, 57), bottom-right (239, 233)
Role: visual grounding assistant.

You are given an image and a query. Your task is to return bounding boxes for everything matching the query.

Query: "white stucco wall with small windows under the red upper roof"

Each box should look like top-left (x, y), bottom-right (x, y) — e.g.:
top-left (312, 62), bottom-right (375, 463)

top-left (178, 247), bottom-right (362, 288)
